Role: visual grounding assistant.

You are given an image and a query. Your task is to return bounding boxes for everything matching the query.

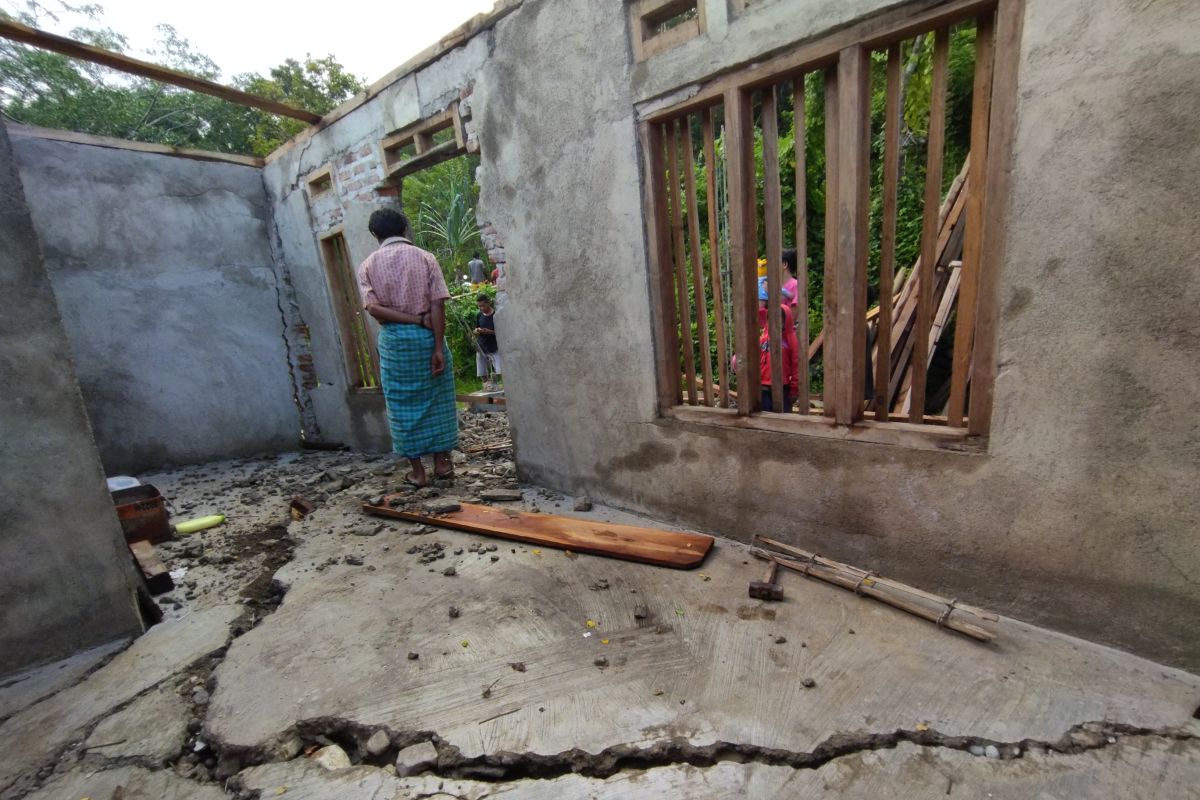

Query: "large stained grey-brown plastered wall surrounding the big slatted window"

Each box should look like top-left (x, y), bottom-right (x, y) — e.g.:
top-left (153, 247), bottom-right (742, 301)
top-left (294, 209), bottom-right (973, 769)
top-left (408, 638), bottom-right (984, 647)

top-left (473, 0), bottom-right (1200, 669)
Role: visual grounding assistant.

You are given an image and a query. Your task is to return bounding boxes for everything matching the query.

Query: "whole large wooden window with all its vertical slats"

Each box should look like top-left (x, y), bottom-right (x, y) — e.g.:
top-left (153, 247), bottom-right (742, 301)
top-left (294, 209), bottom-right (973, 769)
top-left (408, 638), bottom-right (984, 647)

top-left (640, 0), bottom-right (1024, 435)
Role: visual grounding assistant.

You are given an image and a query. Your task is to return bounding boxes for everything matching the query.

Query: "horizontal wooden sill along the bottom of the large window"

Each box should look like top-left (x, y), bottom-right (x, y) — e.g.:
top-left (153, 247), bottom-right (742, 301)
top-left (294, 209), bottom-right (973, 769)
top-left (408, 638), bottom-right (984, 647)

top-left (664, 405), bottom-right (988, 455)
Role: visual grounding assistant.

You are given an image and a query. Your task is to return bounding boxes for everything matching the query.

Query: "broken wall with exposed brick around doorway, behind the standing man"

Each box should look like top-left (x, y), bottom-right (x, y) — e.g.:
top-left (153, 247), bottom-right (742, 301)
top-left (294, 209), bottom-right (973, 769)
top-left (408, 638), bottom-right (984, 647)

top-left (263, 18), bottom-right (506, 451)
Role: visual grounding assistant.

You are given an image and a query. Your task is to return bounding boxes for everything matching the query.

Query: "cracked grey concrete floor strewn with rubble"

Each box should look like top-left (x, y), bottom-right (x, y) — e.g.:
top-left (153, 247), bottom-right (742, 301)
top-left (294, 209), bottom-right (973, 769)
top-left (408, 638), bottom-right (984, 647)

top-left (0, 412), bottom-right (1200, 800)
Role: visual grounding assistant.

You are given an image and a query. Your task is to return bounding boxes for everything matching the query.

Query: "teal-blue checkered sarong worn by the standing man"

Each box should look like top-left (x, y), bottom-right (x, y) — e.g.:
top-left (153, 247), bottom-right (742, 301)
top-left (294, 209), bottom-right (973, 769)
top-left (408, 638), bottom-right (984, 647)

top-left (379, 324), bottom-right (458, 458)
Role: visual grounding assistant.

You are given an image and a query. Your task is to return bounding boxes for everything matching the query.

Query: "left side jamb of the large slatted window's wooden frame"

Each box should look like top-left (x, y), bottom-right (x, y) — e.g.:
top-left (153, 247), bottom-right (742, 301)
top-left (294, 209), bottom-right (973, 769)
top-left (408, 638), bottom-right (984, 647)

top-left (641, 124), bottom-right (683, 411)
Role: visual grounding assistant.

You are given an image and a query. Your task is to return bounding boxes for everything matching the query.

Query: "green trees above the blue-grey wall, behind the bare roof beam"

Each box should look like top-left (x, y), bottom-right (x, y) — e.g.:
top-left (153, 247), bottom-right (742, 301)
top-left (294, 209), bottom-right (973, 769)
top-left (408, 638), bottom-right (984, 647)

top-left (0, 0), bottom-right (362, 156)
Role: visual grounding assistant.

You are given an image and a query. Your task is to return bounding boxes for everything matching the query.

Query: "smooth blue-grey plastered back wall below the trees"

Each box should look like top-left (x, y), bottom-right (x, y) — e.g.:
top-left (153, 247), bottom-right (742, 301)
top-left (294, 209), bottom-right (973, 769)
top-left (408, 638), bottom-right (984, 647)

top-left (13, 136), bottom-right (300, 474)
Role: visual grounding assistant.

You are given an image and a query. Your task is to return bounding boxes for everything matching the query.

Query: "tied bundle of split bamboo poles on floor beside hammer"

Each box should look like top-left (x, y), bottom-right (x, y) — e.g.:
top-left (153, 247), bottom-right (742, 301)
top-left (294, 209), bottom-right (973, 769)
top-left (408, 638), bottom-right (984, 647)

top-left (754, 536), bottom-right (1000, 642)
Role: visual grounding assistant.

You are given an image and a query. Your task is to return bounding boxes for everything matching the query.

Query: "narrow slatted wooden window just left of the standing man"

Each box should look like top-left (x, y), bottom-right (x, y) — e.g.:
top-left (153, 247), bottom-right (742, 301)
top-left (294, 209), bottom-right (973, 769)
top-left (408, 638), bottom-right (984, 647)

top-left (320, 228), bottom-right (382, 391)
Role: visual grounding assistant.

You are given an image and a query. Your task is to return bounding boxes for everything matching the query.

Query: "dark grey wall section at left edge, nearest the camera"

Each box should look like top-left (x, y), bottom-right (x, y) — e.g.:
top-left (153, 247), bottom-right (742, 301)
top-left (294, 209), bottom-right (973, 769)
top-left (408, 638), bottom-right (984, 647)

top-left (0, 122), bottom-right (142, 675)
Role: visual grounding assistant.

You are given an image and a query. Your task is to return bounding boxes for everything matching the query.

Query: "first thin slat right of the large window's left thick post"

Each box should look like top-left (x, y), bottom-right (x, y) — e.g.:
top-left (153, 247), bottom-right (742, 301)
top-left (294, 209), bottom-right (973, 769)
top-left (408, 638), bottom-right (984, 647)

top-left (762, 86), bottom-right (786, 413)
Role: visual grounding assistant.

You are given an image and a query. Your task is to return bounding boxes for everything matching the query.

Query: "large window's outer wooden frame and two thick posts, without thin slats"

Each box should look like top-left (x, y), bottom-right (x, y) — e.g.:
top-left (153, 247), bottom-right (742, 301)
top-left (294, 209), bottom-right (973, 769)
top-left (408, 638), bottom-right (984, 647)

top-left (640, 0), bottom-right (1025, 452)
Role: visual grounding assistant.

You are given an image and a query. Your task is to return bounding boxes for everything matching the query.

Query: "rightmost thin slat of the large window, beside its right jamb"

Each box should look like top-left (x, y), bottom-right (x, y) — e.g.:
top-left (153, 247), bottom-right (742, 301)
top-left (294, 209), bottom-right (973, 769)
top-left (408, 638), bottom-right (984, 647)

top-left (946, 14), bottom-right (994, 427)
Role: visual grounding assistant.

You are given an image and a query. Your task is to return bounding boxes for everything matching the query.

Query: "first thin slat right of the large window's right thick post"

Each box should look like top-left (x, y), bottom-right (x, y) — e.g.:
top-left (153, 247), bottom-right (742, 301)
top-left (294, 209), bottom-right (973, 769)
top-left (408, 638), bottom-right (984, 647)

top-left (875, 44), bottom-right (901, 422)
